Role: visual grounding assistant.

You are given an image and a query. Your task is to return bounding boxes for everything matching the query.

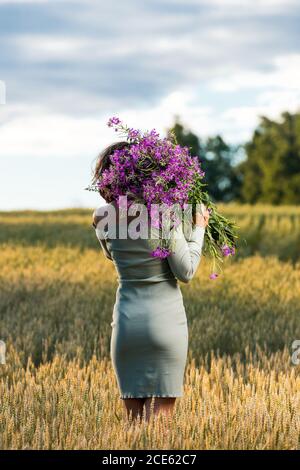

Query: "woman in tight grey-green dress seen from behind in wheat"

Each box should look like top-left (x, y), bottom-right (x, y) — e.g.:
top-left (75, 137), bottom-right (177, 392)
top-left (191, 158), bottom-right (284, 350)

top-left (93, 142), bottom-right (209, 419)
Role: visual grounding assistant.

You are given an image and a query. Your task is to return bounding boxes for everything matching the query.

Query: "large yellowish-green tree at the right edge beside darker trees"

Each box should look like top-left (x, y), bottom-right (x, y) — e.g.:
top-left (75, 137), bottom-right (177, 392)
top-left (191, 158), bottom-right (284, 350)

top-left (238, 112), bottom-right (300, 204)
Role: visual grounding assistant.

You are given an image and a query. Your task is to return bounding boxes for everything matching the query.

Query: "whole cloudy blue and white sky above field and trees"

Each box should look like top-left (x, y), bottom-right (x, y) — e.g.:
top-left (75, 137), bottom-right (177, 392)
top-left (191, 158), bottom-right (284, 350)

top-left (0, 0), bottom-right (300, 210)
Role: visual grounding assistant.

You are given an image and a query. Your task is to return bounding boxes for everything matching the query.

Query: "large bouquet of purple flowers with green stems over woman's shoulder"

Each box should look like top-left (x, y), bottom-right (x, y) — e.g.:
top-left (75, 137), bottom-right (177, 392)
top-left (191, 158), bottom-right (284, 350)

top-left (86, 117), bottom-right (238, 279)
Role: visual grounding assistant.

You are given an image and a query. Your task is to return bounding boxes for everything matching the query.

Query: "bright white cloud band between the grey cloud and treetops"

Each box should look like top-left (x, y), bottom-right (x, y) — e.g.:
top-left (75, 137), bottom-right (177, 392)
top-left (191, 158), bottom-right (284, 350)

top-left (5, 77), bottom-right (300, 165)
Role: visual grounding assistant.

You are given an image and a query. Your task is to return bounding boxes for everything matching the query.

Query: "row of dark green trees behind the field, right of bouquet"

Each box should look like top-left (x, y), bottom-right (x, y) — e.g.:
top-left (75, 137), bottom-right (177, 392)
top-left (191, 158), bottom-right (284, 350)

top-left (169, 112), bottom-right (300, 204)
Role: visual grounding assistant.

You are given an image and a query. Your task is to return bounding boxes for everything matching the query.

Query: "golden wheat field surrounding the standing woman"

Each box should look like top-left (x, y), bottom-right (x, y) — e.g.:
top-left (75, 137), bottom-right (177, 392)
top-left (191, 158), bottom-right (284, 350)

top-left (0, 204), bottom-right (300, 450)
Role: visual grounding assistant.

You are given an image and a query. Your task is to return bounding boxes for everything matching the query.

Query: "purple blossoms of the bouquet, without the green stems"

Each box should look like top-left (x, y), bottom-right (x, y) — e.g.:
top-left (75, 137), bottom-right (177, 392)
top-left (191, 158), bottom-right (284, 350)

top-left (96, 116), bottom-right (235, 266)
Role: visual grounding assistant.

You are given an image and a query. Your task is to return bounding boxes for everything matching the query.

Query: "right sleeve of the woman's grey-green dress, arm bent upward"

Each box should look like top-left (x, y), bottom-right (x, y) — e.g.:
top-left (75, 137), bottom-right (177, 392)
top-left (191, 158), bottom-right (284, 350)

top-left (167, 225), bottom-right (205, 283)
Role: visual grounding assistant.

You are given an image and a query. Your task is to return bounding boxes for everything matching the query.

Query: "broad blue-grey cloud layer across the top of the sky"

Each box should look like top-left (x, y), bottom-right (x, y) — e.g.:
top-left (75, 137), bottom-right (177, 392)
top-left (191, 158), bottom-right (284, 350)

top-left (0, 0), bottom-right (300, 114)
